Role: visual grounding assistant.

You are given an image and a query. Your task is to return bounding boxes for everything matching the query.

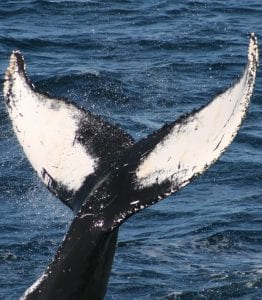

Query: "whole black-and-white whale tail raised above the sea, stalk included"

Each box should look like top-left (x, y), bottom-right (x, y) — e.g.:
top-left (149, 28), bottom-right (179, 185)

top-left (4, 34), bottom-right (258, 299)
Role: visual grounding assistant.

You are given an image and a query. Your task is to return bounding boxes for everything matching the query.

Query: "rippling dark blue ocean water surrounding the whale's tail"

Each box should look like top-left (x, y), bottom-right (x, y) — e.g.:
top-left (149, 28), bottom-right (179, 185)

top-left (0, 0), bottom-right (262, 300)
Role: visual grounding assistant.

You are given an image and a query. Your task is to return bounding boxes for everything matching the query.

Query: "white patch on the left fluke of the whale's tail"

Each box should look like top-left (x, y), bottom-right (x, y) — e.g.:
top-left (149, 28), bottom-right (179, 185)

top-left (4, 52), bottom-right (97, 191)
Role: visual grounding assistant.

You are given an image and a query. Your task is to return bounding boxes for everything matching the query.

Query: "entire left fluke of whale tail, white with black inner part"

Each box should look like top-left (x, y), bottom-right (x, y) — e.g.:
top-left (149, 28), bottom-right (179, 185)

top-left (4, 51), bottom-right (133, 211)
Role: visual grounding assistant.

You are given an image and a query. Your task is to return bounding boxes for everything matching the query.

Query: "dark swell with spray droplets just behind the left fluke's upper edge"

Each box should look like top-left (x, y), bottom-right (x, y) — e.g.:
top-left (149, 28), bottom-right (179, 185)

top-left (34, 71), bottom-right (143, 118)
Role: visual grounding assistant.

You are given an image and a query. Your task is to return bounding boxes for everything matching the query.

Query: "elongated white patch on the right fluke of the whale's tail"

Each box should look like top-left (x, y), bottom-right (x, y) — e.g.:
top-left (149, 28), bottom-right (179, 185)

top-left (136, 34), bottom-right (258, 189)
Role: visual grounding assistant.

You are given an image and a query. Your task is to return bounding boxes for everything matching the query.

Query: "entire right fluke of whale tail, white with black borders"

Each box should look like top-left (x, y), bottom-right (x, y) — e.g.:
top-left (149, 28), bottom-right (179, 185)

top-left (109, 34), bottom-right (259, 226)
